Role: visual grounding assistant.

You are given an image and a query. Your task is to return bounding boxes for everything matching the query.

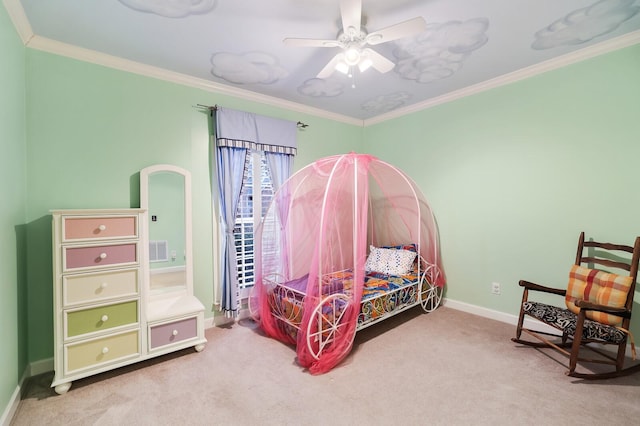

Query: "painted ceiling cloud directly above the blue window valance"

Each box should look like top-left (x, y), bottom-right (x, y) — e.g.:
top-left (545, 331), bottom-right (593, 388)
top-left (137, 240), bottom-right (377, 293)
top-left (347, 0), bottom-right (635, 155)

top-left (211, 52), bottom-right (289, 84)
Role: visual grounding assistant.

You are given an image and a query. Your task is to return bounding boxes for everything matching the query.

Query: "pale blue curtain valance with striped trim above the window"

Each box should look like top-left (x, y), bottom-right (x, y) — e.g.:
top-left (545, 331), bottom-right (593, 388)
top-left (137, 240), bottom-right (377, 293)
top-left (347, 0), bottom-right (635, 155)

top-left (216, 107), bottom-right (297, 155)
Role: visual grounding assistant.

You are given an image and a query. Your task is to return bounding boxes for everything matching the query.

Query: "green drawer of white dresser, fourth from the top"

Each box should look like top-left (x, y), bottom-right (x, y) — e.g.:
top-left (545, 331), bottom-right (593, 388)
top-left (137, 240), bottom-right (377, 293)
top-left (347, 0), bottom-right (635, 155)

top-left (65, 300), bottom-right (138, 338)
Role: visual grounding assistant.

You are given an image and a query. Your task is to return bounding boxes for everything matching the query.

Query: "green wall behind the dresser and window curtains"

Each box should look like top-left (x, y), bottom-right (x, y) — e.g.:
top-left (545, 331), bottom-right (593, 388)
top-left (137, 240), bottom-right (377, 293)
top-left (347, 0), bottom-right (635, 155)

top-left (26, 49), bottom-right (362, 362)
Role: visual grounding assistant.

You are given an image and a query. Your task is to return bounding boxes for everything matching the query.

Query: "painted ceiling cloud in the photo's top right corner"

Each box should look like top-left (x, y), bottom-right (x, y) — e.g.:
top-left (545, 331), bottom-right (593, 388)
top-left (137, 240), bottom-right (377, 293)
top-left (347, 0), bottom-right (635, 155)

top-left (531, 0), bottom-right (640, 50)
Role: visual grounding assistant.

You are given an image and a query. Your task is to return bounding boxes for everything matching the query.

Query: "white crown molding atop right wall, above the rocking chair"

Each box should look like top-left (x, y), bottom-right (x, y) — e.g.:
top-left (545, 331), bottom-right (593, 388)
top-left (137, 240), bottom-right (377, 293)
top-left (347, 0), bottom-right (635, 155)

top-left (363, 30), bottom-right (640, 127)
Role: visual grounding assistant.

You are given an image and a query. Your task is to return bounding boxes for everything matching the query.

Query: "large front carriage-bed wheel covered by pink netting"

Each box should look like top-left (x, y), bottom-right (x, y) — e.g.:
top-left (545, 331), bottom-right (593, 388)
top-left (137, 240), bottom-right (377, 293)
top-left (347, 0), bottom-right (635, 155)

top-left (307, 293), bottom-right (356, 360)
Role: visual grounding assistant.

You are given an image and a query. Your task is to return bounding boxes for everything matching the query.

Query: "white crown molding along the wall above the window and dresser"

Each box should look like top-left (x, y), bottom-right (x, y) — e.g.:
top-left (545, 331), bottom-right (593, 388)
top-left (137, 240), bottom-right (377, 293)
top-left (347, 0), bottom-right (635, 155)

top-left (23, 34), bottom-right (362, 127)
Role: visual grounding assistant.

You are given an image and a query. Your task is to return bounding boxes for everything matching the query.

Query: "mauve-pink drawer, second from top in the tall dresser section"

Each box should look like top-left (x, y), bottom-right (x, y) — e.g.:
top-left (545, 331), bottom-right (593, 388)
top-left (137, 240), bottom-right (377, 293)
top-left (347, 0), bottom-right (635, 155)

top-left (63, 242), bottom-right (138, 271)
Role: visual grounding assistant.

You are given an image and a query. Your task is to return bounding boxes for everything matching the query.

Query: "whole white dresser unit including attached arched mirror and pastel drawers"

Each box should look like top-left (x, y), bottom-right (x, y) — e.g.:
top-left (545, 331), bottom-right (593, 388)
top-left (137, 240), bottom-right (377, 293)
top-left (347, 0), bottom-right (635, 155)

top-left (51, 165), bottom-right (207, 394)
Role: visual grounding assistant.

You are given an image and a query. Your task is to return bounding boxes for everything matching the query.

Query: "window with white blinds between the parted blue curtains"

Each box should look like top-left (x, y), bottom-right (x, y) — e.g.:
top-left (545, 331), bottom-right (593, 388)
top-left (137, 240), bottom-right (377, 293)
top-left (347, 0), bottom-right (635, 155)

top-left (233, 150), bottom-right (274, 298)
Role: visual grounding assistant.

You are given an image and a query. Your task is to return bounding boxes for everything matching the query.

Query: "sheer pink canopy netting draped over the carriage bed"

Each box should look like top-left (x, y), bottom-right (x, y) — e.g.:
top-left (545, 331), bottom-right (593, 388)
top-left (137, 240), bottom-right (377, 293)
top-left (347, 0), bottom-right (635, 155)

top-left (250, 153), bottom-right (445, 374)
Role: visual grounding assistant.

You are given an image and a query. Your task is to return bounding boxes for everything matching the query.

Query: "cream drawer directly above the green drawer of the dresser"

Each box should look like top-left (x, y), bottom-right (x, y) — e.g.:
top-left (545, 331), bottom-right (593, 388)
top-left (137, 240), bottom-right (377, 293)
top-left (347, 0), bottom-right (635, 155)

top-left (62, 269), bottom-right (138, 307)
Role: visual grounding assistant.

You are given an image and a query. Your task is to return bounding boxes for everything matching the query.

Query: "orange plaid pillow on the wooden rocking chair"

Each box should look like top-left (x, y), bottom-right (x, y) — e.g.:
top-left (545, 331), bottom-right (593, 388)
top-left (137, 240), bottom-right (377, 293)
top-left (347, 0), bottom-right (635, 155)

top-left (565, 265), bottom-right (633, 326)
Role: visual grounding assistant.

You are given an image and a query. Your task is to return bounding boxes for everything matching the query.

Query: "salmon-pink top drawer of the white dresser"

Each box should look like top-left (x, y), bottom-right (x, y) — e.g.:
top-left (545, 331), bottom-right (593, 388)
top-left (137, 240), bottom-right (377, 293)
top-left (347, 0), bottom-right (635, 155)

top-left (62, 216), bottom-right (138, 241)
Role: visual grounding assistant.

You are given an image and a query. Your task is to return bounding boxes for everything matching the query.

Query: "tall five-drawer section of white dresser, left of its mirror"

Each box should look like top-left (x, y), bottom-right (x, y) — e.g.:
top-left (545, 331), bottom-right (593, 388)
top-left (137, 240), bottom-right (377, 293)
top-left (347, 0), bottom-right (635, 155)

top-left (51, 209), bottom-right (145, 394)
